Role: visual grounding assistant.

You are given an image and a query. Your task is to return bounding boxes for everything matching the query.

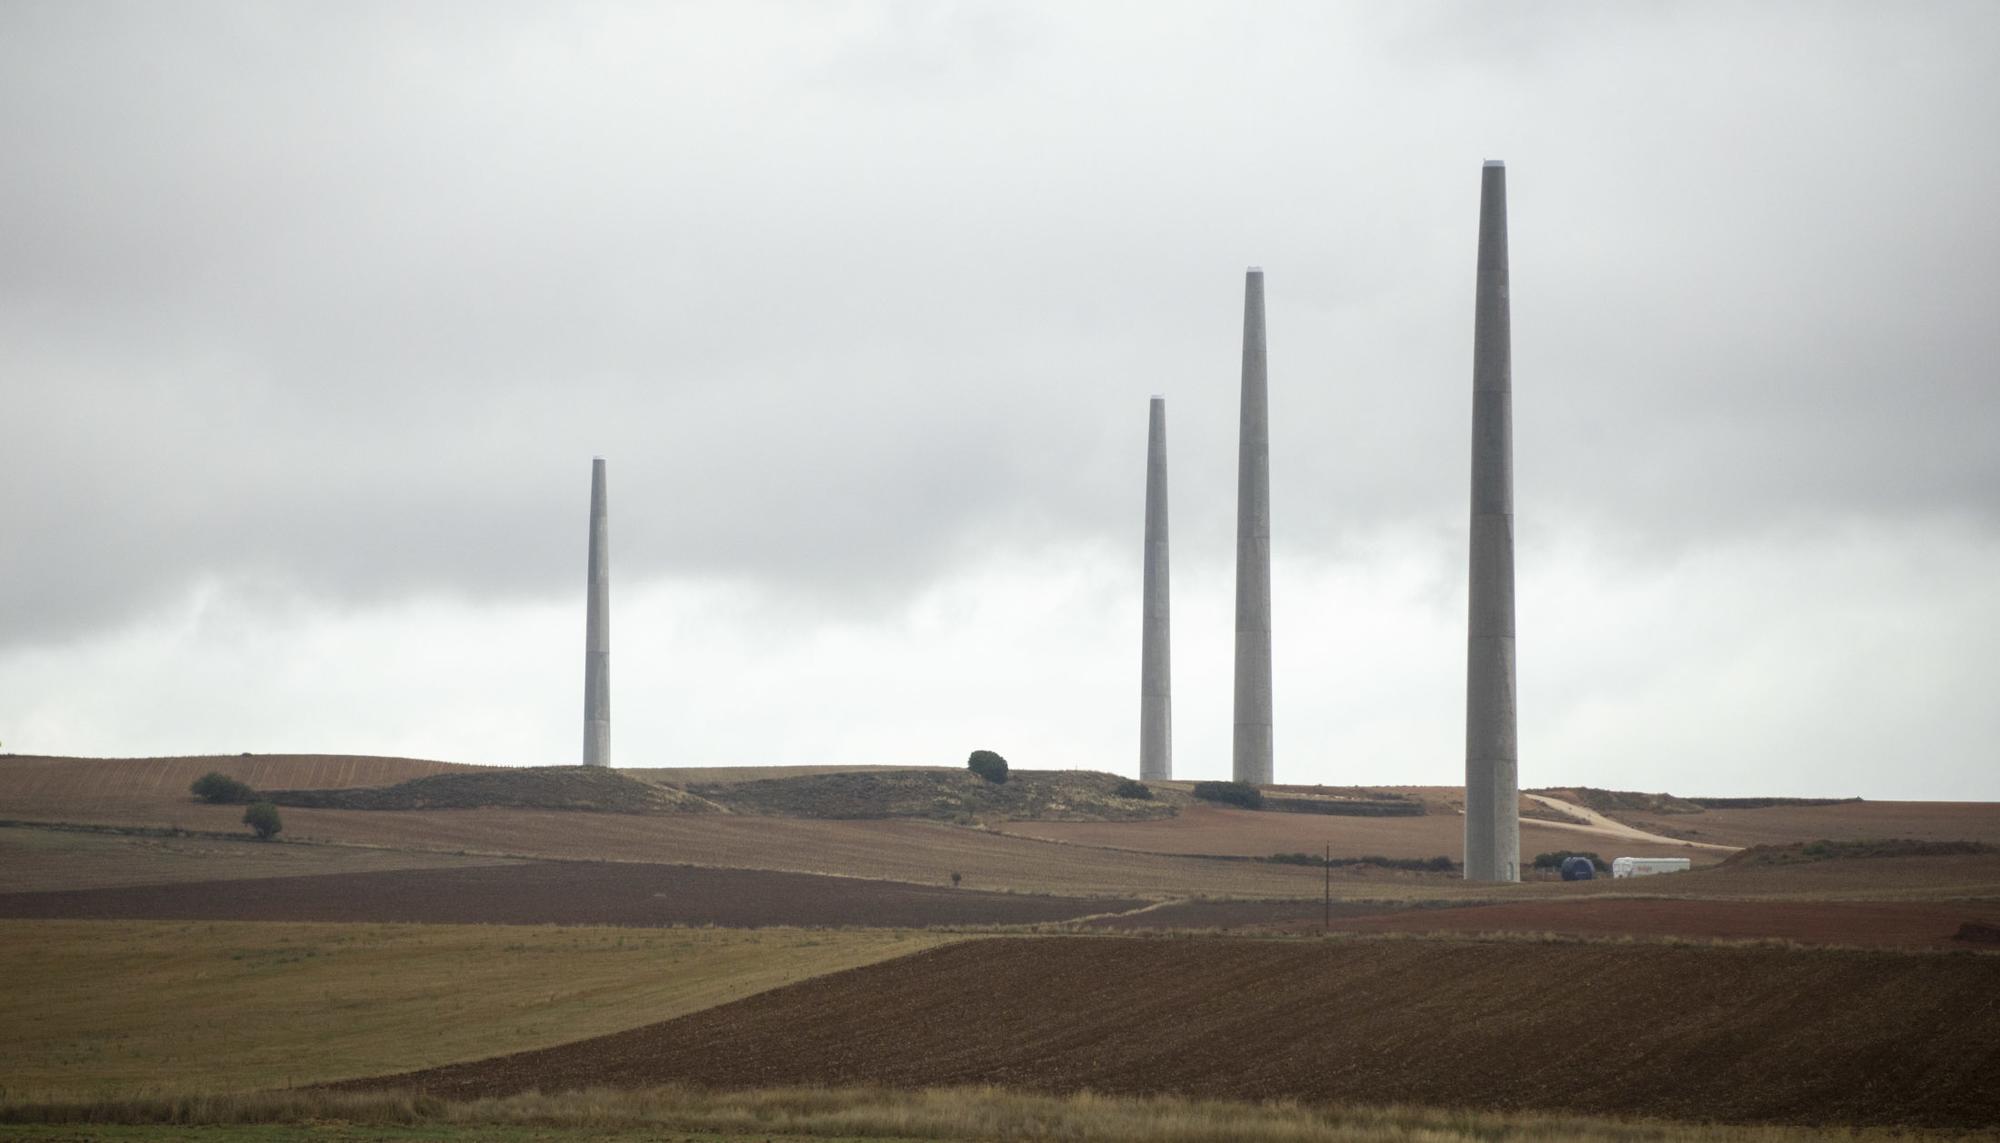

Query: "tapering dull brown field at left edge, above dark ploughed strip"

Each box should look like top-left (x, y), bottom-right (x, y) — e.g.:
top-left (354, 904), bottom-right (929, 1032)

top-left (0, 825), bottom-right (512, 893)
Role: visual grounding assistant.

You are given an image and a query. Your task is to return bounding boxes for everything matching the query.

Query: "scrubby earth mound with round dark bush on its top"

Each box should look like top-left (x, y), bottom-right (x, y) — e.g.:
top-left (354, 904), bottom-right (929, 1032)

top-left (688, 769), bottom-right (1186, 823)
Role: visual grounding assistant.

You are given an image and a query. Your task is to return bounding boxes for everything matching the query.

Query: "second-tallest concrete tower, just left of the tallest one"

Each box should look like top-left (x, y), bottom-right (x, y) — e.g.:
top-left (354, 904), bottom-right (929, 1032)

top-left (1232, 266), bottom-right (1272, 785)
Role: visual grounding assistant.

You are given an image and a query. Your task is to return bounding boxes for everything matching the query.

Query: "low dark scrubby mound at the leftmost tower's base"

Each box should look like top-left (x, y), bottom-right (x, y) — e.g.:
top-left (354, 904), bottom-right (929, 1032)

top-left (258, 765), bottom-right (720, 813)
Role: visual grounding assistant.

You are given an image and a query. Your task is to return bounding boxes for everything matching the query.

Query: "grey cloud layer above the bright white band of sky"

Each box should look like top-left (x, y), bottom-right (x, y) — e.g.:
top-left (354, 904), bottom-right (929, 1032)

top-left (0, 4), bottom-right (2000, 639)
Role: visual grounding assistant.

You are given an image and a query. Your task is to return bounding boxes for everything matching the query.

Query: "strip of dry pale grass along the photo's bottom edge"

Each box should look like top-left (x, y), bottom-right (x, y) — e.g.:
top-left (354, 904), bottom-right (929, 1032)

top-left (0, 1087), bottom-right (1924, 1143)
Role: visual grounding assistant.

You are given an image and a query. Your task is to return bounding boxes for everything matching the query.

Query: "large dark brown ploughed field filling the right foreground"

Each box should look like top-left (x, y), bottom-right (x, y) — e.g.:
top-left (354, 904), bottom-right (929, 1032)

top-left (352, 937), bottom-right (2000, 1127)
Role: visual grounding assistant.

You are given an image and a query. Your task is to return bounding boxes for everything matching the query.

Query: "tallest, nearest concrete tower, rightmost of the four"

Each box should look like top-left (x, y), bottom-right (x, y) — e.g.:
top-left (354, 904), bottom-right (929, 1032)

top-left (1466, 160), bottom-right (1520, 881)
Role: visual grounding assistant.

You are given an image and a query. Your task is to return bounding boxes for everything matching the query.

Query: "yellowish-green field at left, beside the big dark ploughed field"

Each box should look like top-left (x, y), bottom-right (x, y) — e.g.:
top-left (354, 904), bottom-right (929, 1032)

top-left (0, 921), bottom-right (962, 1101)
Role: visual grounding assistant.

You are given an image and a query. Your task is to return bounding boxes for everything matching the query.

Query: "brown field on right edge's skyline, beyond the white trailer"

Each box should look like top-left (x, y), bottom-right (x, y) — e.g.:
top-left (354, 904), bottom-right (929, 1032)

top-left (1600, 801), bottom-right (2000, 847)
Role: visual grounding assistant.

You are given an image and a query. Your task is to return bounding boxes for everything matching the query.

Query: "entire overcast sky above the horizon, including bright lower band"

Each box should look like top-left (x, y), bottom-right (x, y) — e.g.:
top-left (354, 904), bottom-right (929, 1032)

top-left (0, 0), bottom-right (2000, 799)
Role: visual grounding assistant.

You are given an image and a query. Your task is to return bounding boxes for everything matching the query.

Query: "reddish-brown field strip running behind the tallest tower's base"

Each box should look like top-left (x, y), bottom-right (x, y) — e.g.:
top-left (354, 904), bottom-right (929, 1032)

top-left (998, 805), bottom-right (1728, 865)
